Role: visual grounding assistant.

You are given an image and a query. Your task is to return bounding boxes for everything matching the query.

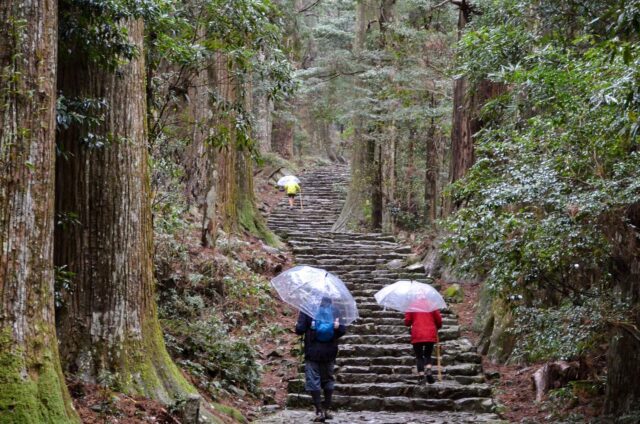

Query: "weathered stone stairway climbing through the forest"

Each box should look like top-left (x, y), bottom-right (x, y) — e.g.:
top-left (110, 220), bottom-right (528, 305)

top-left (258, 167), bottom-right (500, 424)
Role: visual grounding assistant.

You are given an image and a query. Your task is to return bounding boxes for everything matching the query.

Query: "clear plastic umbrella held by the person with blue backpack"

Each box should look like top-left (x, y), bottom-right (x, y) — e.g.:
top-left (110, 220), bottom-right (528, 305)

top-left (271, 266), bottom-right (358, 325)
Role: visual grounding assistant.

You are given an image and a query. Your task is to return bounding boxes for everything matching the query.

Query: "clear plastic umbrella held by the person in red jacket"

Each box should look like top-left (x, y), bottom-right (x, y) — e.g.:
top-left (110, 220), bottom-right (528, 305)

top-left (374, 280), bottom-right (447, 312)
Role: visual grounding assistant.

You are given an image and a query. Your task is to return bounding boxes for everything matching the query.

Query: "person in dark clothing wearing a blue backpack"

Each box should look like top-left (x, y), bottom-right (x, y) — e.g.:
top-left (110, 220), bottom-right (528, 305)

top-left (296, 297), bottom-right (346, 422)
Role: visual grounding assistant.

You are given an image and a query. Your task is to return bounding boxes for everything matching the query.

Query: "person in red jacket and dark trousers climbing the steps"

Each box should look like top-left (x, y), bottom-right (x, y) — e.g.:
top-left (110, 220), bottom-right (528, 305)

top-left (404, 310), bottom-right (442, 384)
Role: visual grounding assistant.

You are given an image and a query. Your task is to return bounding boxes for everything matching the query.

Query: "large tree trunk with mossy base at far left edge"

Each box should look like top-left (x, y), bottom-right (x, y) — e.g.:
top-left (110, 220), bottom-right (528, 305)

top-left (0, 0), bottom-right (78, 423)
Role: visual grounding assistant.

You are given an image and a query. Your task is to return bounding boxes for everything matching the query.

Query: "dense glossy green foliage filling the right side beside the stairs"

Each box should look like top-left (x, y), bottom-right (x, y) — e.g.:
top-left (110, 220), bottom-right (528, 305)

top-left (445, 0), bottom-right (640, 359)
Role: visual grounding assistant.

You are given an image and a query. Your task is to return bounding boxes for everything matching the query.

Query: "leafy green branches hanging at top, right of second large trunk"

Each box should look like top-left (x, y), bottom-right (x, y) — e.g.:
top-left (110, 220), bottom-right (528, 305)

top-left (146, 0), bottom-right (295, 151)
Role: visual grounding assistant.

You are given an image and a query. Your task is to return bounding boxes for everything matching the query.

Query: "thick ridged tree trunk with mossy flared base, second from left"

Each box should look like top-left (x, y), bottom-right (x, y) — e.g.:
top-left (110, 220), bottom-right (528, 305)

top-left (55, 20), bottom-right (195, 403)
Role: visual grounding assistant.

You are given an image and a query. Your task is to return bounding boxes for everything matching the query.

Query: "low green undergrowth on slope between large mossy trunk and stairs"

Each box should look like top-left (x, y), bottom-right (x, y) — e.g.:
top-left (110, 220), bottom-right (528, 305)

top-left (155, 226), bottom-right (283, 398)
